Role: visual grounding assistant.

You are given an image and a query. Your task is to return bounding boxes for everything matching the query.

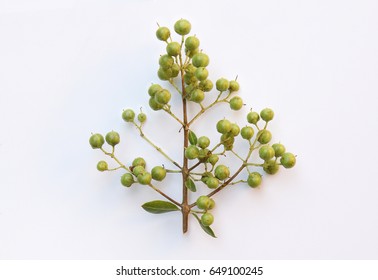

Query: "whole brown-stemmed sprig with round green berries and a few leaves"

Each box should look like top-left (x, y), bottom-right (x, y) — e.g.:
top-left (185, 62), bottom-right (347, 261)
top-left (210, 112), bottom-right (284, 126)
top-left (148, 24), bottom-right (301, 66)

top-left (89, 19), bottom-right (296, 237)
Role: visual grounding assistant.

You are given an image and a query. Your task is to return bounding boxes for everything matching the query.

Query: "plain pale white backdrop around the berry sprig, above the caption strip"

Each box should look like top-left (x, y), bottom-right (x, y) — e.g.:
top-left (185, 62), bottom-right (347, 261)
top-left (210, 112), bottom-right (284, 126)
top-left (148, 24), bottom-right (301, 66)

top-left (0, 0), bottom-right (378, 259)
